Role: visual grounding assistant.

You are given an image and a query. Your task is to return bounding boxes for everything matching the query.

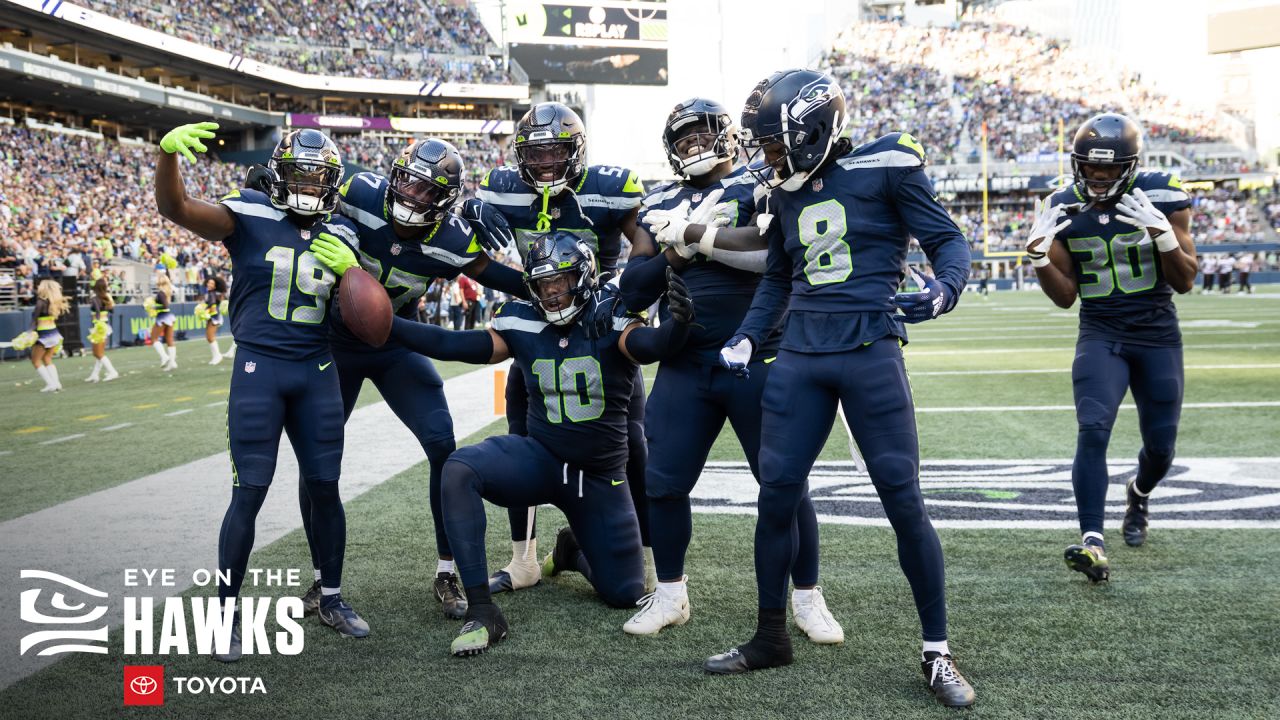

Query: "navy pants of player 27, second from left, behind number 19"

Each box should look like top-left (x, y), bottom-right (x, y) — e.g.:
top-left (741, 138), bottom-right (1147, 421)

top-left (298, 347), bottom-right (457, 562)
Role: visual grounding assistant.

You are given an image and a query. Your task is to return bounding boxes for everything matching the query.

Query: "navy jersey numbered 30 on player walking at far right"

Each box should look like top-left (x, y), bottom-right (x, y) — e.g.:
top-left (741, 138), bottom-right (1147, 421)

top-left (1050, 172), bottom-right (1192, 346)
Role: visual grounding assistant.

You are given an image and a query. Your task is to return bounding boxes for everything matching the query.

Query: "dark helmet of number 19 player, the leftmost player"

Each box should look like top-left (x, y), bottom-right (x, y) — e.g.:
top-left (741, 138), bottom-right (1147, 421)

top-left (266, 129), bottom-right (343, 215)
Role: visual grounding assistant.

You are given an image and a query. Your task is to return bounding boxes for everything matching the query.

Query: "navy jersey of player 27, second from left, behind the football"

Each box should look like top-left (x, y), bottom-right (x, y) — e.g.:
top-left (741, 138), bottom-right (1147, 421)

top-left (333, 173), bottom-right (484, 348)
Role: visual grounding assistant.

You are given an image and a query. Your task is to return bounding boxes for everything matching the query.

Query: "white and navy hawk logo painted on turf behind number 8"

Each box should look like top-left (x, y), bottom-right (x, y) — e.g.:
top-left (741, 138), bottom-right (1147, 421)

top-left (692, 457), bottom-right (1280, 529)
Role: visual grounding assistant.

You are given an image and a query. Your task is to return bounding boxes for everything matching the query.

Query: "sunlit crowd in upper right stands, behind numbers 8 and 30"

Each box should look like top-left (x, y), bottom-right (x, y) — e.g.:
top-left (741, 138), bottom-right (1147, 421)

top-left (824, 15), bottom-right (1228, 164)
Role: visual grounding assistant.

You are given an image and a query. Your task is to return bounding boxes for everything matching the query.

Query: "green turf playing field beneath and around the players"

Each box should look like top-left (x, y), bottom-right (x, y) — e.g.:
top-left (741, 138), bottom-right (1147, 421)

top-left (0, 292), bottom-right (1280, 719)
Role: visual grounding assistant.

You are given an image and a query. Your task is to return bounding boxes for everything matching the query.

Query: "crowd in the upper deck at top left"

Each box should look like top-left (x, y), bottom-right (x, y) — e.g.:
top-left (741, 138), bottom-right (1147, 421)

top-left (88, 0), bottom-right (511, 83)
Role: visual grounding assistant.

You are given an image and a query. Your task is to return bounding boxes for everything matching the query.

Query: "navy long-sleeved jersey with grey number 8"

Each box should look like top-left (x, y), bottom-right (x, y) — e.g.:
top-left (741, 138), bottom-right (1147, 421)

top-left (741, 132), bottom-right (969, 352)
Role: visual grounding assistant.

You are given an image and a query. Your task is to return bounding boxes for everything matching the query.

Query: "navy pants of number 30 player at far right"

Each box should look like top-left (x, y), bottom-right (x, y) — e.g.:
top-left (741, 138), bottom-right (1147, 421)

top-left (1071, 340), bottom-right (1183, 533)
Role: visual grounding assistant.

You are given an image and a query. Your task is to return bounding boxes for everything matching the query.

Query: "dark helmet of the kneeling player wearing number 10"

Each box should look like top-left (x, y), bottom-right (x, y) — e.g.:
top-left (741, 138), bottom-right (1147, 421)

top-left (525, 231), bottom-right (595, 325)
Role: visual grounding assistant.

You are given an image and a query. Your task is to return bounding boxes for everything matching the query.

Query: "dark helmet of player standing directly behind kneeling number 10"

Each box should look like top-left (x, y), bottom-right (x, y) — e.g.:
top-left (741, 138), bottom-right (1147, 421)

top-left (512, 102), bottom-right (586, 195)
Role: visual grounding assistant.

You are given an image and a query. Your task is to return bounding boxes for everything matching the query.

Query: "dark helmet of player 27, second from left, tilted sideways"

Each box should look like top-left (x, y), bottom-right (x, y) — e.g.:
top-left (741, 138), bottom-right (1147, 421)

top-left (387, 140), bottom-right (462, 225)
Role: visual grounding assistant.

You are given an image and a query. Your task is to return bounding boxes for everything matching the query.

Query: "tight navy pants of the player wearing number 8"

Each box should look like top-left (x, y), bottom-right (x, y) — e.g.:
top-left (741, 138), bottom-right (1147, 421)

top-left (755, 338), bottom-right (947, 641)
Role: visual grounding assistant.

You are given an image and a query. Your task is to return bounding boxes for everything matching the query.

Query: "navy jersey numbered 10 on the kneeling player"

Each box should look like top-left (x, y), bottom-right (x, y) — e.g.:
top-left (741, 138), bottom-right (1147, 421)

top-left (490, 286), bottom-right (640, 477)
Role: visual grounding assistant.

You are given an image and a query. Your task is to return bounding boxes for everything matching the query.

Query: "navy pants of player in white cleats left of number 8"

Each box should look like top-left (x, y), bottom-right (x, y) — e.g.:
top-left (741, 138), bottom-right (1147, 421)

top-left (645, 360), bottom-right (818, 587)
